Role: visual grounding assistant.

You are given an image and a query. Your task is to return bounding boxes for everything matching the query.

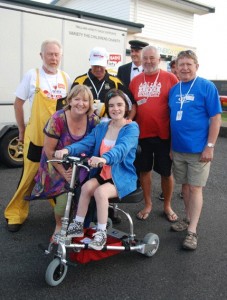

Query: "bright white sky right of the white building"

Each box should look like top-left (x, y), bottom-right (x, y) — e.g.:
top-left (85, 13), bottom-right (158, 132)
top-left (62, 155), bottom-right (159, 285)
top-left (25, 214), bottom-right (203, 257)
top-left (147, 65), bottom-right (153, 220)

top-left (195, 0), bottom-right (227, 80)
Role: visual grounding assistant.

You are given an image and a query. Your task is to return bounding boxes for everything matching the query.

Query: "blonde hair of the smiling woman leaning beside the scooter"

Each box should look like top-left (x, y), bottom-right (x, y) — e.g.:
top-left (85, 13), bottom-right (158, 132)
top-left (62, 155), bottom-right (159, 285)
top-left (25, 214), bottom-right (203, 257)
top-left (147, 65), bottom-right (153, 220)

top-left (65, 84), bottom-right (94, 115)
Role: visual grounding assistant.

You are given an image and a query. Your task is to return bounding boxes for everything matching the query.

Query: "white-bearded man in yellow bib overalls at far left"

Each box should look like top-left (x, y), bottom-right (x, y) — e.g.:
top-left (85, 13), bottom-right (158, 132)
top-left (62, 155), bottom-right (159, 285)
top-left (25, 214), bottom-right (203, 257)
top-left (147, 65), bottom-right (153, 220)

top-left (5, 40), bottom-right (71, 232)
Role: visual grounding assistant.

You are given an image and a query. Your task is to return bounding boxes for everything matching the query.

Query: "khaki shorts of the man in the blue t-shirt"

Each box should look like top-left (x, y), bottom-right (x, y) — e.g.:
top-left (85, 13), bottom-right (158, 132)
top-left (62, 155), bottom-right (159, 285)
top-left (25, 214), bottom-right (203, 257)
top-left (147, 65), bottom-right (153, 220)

top-left (173, 151), bottom-right (210, 186)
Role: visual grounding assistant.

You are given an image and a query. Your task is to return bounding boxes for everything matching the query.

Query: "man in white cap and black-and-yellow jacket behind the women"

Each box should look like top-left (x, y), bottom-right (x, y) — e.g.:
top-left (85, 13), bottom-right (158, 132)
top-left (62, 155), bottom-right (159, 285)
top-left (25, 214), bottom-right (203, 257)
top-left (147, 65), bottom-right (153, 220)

top-left (72, 47), bottom-right (135, 119)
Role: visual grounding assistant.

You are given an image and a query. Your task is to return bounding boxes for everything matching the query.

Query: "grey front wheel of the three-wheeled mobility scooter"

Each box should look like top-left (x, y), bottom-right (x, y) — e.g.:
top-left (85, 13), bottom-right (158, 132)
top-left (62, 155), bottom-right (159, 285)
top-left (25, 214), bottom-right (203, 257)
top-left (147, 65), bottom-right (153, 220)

top-left (45, 258), bottom-right (68, 286)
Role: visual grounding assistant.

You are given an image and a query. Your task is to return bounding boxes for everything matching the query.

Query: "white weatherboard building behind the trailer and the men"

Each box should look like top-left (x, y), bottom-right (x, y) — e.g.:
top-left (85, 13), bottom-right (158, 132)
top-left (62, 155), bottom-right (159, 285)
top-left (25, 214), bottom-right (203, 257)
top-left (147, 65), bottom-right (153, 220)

top-left (52, 0), bottom-right (215, 68)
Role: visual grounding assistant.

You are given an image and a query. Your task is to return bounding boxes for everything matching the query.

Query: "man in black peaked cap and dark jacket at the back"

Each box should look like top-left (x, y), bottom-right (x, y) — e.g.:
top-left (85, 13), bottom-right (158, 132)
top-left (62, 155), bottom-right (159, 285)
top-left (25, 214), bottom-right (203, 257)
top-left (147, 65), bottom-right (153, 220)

top-left (117, 40), bottom-right (148, 87)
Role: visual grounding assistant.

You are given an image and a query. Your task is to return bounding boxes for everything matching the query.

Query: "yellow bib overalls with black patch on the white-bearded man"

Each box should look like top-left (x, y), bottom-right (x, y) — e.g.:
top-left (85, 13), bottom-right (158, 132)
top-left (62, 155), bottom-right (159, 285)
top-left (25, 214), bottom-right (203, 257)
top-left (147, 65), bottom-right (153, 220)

top-left (5, 69), bottom-right (67, 224)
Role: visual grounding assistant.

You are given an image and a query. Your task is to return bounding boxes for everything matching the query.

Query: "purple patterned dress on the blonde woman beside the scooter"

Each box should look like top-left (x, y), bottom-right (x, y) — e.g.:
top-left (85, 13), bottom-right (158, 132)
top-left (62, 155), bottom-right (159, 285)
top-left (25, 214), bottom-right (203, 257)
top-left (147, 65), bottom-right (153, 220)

top-left (27, 109), bottom-right (99, 200)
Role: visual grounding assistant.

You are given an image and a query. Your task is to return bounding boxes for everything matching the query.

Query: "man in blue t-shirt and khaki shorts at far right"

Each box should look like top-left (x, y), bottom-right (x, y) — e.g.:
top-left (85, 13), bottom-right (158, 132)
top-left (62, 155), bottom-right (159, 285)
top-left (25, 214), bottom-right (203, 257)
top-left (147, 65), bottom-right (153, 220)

top-left (169, 50), bottom-right (222, 250)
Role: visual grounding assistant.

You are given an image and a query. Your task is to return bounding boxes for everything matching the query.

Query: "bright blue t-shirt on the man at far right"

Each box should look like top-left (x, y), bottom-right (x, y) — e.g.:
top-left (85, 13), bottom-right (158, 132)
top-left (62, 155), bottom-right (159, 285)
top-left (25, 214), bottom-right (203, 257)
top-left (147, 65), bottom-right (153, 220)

top-left (169, 77), bottom-right (222, 153)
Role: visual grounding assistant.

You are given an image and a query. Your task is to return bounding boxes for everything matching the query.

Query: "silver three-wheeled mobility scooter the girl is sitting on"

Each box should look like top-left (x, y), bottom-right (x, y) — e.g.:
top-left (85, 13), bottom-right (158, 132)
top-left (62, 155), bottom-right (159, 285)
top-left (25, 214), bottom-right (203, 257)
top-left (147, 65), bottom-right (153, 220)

top-left (45, 156), bottom-right (159, 286)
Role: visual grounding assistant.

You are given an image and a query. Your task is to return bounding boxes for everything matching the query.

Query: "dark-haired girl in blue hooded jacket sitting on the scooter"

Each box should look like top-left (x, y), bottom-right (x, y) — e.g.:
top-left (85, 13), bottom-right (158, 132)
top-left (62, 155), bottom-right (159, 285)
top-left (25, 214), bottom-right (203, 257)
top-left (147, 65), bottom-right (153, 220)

top-left (54, 89), bottom-right (139, 250)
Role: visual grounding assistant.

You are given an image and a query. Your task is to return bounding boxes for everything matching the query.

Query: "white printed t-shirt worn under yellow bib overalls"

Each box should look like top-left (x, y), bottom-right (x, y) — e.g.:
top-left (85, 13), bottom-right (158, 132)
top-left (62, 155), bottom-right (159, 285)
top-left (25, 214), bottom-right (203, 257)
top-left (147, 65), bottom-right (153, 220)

top-left (15, 68), bottom-right (72, 106)
